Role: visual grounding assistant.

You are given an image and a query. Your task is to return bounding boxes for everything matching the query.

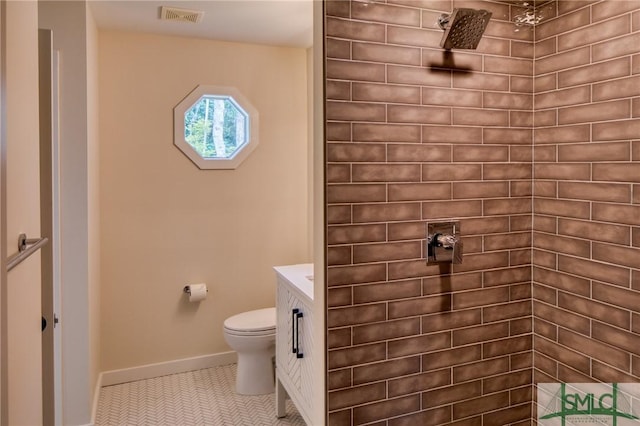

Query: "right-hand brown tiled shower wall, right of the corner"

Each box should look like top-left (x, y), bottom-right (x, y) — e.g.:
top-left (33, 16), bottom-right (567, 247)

top-left (533, 0), bottom-right (640, 390)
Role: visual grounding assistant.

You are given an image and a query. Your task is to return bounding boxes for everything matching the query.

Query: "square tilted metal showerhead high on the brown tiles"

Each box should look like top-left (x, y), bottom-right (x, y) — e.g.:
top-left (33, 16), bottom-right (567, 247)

top-left (438, 8), bottom-right (491, 50)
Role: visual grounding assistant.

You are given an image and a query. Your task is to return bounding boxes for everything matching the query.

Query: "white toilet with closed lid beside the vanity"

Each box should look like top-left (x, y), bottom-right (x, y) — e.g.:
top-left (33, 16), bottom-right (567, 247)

top-left (224, 308), bottom-right (276, 395)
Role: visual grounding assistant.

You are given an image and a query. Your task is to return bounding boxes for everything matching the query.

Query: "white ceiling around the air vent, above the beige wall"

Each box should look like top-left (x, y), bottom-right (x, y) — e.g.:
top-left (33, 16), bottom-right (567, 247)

top-left (89, 0), bottom-right (313, 48)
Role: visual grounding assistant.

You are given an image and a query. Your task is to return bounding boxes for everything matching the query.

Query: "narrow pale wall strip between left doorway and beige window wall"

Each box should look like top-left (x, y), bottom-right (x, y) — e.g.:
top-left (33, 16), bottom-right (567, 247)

top-left (39, 0), bottom-right (99, 426)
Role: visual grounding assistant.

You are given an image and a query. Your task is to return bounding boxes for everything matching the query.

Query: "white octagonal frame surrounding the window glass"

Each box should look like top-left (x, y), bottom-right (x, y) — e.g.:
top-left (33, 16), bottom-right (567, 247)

top-left (173, 85), bottom-right (259, 170)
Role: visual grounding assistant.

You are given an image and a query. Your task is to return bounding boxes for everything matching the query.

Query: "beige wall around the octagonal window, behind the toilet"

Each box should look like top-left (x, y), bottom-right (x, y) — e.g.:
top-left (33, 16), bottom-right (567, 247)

top-left (99, 31), bottom-right (310, 370)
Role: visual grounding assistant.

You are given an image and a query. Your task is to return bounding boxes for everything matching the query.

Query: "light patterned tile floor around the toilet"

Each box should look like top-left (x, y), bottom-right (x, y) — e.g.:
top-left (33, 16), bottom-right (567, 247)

top-left (96, 364), bottom-right (305, 426)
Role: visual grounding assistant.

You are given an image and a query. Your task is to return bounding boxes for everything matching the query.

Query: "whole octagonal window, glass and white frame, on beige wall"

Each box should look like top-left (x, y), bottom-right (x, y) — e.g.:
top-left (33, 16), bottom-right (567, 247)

top-left (174, 86), bottom-right (258, 169)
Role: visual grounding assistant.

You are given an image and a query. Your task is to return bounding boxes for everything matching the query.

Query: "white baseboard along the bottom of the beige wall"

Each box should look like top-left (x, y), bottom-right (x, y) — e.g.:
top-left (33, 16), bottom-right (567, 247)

top-left (100, 351), bottom-right (238, 388)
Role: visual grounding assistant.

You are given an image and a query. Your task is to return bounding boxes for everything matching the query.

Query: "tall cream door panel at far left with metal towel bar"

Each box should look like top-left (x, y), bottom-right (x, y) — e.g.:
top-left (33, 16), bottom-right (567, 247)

top-left (2, 1), bottom-right (42, 425)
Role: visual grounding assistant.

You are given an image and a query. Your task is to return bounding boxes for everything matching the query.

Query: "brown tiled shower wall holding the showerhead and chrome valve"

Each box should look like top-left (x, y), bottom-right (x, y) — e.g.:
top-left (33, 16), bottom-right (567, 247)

top-left (325, 0), bottom-right (536, 426)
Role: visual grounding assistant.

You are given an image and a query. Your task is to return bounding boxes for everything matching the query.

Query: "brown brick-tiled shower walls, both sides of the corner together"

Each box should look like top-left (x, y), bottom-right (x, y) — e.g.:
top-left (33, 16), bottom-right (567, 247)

top-left (325, 0), bottom-right (640, 426)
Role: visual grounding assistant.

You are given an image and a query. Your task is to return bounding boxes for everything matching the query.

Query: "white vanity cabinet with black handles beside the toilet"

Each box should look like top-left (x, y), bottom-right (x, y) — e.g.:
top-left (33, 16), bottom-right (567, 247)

top-left (274, 264), bottom-right (314, 425)
